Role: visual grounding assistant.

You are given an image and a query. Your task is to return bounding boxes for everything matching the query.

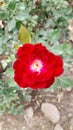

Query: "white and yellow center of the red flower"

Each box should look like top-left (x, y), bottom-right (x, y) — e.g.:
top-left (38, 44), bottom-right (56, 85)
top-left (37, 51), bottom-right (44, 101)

top-left (31, 60), bottom-right (43, 73)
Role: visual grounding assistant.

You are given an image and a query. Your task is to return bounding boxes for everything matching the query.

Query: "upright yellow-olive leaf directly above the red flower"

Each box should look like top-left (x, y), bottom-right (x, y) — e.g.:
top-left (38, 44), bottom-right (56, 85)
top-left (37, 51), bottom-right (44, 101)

top-left (19, 25), bottom-right (31, 44)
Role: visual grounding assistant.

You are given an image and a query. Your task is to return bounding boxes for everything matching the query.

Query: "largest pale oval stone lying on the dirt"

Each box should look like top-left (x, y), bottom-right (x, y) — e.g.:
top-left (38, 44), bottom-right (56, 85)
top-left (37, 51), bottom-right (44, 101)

top-left (41, 103), bottom-right (60, 123)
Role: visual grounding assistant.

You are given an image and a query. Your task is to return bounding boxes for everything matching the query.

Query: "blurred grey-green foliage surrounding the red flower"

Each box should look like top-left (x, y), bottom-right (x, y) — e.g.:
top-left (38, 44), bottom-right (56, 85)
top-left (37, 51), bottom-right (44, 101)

top-left (0, 0), bottom-right (73, 115)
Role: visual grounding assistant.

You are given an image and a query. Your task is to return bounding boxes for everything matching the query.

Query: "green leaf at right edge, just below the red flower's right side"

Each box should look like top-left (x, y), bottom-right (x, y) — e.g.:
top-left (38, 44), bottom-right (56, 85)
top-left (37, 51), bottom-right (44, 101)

top-left (59, 76), bottom-right (73, 88)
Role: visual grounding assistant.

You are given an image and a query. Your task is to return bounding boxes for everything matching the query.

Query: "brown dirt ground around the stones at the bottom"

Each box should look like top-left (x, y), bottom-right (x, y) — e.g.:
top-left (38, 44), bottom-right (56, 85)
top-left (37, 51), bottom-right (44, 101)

top-left (0, 85), bottom-right (73, 130)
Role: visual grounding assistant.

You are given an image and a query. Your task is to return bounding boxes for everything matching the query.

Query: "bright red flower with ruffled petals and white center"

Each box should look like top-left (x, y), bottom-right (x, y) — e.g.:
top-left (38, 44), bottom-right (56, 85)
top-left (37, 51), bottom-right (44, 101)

top-left (13, 43), bottom-right (64, 89)
